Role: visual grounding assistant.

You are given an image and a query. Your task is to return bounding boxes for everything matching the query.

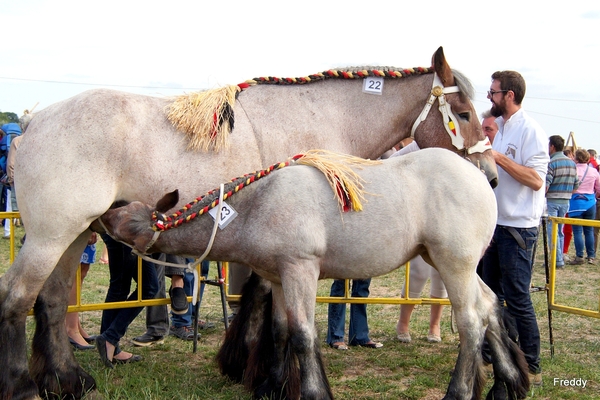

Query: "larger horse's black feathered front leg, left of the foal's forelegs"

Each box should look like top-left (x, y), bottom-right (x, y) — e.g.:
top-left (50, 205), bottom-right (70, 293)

top-left (216, 273), bottom-right (273, 385)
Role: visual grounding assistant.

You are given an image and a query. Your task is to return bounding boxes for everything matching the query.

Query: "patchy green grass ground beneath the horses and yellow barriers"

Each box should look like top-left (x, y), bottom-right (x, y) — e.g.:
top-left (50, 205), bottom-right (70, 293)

top-left (0, 223), bottom-right (600, 400)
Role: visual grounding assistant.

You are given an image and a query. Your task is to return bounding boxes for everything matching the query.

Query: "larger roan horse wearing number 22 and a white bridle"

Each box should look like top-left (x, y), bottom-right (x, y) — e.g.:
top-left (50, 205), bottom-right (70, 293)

top-left (0, 48), bottom-right (497, 400)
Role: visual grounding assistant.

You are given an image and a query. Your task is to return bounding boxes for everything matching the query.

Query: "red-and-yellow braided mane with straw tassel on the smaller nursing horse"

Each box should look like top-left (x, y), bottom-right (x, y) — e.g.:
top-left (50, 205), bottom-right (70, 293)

top-left (152, 150), bottom-right (381, 231)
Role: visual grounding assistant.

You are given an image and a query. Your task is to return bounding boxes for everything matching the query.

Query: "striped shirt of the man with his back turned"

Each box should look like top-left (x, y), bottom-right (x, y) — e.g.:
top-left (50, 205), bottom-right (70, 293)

top-left (546, 151), bottom-right (579, 204)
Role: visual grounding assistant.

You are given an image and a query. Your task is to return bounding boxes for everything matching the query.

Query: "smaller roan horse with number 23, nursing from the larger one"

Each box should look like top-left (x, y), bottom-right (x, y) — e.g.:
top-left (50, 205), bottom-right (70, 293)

top-left (101, 149), bottom-right (529, 399)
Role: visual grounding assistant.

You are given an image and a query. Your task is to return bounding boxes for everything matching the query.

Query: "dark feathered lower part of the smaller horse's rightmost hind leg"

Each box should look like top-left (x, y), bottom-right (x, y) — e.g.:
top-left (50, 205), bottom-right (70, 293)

top-left (485, 302), bottom-right (529, 400)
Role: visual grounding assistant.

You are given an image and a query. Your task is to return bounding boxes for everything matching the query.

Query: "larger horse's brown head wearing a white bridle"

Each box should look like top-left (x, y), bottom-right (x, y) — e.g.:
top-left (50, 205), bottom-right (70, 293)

top-left (411, 47), bottom-right (498, 187)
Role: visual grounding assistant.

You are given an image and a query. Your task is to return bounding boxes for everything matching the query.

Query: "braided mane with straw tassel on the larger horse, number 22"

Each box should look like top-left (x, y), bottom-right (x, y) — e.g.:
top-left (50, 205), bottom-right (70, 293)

top-left (166, 67), bottom-right (433, 151)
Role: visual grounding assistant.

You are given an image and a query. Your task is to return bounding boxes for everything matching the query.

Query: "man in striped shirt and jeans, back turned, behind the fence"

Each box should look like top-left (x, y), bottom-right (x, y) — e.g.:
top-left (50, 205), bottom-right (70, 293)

top-left (546, 135), bottom-right (579, 268)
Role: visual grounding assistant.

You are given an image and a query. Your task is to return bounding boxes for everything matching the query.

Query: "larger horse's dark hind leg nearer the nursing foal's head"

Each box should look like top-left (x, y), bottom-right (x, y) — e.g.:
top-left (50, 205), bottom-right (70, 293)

top-left (28, 230), bottom-right (96, 399)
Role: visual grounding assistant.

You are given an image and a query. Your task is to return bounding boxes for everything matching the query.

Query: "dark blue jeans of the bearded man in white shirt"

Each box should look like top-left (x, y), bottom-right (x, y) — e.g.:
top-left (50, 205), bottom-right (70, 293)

top-left (483, 225), bottom-right (541, 372)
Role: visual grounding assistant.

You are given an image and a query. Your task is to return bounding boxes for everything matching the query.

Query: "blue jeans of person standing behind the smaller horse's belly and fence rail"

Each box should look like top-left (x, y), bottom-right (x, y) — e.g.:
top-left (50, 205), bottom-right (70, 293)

top-left (327, 278), bottom-right (371, 346)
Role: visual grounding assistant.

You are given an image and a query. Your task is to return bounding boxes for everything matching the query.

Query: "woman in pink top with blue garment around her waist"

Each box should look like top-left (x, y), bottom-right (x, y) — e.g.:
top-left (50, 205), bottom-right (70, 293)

top-left (569, 149), bottom-right (600, 265)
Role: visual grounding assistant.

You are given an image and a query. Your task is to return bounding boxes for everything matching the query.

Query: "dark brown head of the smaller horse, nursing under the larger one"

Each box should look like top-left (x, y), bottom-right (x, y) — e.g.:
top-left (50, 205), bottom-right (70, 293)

top-left (99, 190), bottom-right (179, 253)
